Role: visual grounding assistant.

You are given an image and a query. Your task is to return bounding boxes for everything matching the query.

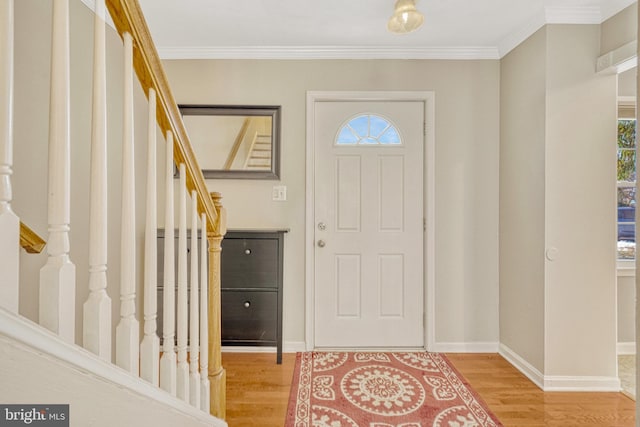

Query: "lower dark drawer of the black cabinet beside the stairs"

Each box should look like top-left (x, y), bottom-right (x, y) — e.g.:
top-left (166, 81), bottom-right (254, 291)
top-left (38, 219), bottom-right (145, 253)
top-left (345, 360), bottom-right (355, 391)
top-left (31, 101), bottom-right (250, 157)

top-left (222, 290), bottom-right (278, 343)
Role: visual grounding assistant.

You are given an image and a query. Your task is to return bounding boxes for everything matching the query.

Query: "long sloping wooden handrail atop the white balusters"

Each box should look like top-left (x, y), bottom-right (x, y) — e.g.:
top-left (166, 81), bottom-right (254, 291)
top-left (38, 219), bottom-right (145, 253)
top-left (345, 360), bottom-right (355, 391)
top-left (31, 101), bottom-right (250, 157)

top-left (106, 0), bottom-right (220, 234)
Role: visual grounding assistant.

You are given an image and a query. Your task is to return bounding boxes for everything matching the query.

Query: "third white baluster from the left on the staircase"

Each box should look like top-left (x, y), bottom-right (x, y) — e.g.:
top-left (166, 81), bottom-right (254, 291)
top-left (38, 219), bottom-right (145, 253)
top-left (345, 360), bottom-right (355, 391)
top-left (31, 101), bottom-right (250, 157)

top-left (82, 0), bottom-right (111, 361)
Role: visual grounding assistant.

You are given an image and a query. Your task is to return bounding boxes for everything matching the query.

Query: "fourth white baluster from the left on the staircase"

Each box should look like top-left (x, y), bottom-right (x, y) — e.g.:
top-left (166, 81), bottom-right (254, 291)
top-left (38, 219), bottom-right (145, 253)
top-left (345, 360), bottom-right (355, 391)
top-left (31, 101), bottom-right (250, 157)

top-left (116, 33), bottom-right (140, 375)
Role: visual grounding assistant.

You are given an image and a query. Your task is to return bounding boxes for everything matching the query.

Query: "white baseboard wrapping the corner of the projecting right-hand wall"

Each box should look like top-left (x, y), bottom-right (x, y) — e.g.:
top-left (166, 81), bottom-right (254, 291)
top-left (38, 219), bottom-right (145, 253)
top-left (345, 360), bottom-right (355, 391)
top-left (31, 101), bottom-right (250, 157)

top-left (498, 344), bottom-right (621, 392)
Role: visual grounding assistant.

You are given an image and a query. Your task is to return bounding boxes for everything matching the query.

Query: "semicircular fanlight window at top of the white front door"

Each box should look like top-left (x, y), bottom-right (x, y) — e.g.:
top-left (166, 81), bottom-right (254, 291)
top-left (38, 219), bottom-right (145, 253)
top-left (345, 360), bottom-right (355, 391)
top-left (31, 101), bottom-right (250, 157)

top-left (336, 114), bottom-right (402, 145)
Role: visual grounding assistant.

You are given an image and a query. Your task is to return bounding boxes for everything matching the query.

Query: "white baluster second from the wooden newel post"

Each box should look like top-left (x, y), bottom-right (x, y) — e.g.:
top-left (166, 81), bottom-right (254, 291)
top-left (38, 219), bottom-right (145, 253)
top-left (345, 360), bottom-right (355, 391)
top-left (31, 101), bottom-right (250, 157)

top-left (189, 190), bottom-right (200, 408)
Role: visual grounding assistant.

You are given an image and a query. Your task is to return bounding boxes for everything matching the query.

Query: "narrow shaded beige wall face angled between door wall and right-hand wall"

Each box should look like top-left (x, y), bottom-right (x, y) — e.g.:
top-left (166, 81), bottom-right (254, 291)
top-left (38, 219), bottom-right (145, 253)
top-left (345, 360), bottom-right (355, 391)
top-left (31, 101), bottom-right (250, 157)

top-left (499, 29), bottom-right (547, 372)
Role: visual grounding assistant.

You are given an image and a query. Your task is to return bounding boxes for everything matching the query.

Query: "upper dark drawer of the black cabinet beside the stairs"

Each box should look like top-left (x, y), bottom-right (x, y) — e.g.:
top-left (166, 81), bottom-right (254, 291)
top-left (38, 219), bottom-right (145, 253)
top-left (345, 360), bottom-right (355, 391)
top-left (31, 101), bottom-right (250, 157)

top-left (220, 238), bottom-right (279, 288)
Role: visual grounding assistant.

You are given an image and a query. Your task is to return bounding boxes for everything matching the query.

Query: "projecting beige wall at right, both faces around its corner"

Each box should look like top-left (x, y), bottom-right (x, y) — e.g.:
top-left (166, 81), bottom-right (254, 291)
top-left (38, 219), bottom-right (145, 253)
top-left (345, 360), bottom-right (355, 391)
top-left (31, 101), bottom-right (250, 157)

top-left (500, 25), bottom-right (616, 378)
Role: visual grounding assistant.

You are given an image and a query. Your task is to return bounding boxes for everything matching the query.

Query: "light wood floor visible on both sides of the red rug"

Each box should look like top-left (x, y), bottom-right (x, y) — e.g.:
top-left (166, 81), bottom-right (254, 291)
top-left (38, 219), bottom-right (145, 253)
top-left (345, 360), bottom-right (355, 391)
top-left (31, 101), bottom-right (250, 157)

top-left (222, 353), bottom-right (635, 427)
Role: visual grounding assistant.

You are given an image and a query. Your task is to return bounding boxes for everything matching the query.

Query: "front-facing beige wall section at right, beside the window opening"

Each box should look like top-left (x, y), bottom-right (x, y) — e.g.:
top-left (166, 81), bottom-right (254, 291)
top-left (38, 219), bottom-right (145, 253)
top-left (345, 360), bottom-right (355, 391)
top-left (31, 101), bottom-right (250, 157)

top-left (545, 25), bottom-right (617, 377)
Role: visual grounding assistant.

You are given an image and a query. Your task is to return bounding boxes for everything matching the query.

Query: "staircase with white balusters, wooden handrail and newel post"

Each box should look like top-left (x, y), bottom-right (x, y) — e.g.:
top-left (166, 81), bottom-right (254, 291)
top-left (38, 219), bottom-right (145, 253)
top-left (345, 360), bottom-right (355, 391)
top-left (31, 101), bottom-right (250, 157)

top-left (0, 0), bottom-right (226, 427)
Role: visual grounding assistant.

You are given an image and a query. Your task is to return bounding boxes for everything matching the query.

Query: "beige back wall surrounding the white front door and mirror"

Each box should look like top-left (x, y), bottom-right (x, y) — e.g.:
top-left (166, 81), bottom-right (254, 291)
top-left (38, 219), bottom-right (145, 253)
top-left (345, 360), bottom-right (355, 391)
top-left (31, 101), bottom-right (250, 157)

top-left (165, 60), bottom-right (499, 344)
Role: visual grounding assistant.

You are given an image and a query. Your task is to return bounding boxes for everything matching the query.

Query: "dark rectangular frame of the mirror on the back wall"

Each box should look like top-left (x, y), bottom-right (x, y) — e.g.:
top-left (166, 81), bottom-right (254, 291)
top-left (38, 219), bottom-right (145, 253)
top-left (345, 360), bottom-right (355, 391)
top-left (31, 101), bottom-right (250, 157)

top-left (178, 104), bottom-right (281, 180)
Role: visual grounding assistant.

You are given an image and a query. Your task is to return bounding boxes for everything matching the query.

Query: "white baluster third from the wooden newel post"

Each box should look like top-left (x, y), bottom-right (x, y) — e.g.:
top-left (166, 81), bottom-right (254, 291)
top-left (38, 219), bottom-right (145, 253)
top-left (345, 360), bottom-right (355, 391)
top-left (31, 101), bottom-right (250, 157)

top-left (176, 163), bottom-right (189, 402)
